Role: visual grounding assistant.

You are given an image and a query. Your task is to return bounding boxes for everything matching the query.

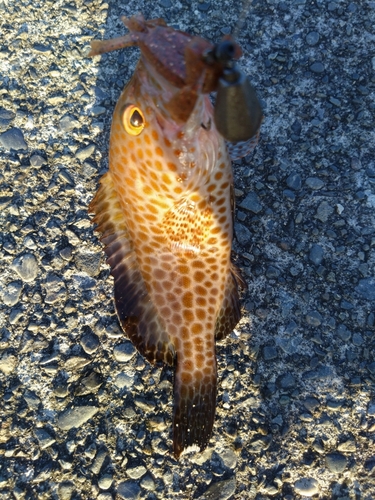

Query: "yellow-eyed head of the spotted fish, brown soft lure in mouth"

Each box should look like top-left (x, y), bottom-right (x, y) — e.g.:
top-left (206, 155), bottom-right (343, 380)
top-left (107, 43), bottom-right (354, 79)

top-left (110, 16), bottom-right (241, 190)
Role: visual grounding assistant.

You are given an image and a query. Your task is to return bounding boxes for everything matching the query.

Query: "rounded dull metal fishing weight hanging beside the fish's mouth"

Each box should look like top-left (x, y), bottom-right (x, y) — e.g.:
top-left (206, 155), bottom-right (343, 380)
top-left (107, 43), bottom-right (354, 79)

top-left (207, 40), bottom-right (263, 143)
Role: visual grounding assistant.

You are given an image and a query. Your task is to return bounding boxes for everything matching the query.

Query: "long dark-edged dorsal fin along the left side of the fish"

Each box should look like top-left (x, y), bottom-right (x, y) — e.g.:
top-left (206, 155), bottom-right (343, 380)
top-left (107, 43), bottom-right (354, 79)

top-left (89, 172), bottom-right (175, 365)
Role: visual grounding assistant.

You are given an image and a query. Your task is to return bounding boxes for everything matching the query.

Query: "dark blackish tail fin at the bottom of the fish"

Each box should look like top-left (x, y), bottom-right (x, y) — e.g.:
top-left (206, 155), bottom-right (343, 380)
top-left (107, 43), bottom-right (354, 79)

top-left (173, 362), bottom-right (217, 459)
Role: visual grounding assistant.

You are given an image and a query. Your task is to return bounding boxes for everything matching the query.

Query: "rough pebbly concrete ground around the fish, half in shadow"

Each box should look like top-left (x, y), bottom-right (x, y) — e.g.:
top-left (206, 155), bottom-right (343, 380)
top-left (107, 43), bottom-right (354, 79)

top-left (0, 0), bottom-right (375, 500)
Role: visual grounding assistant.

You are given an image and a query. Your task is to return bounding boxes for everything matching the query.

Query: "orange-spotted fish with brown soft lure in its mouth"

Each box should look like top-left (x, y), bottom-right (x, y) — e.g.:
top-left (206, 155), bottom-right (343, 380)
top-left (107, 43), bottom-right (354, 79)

top-left (89, 15), bottom-right (262, 458)
